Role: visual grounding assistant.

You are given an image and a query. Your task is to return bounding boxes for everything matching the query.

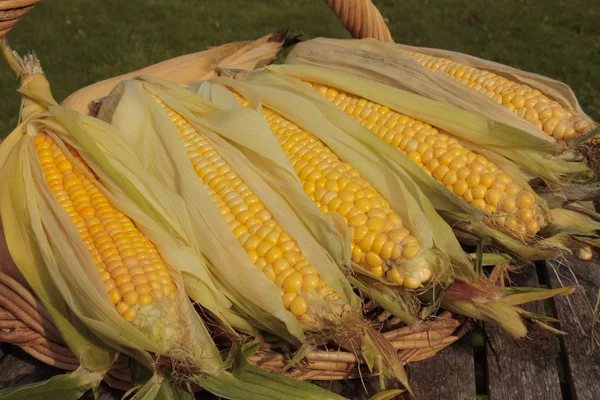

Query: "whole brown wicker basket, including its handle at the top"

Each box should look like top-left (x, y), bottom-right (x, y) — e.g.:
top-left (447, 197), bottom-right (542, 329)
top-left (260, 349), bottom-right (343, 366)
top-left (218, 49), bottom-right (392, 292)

top-left (0, 0), bottom-right (470, 390)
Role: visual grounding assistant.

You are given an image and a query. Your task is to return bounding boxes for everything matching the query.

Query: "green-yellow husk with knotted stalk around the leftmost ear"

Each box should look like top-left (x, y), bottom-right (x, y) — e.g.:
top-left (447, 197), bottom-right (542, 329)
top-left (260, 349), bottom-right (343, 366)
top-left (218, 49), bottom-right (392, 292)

top-left (0, 43), bottom-right (336, 399)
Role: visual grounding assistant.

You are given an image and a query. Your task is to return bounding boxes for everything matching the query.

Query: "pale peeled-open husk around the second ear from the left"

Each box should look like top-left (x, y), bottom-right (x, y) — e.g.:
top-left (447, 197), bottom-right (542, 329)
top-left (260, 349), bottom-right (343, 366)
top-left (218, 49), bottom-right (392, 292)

top-left (99, 77), bottom-right (418, 385)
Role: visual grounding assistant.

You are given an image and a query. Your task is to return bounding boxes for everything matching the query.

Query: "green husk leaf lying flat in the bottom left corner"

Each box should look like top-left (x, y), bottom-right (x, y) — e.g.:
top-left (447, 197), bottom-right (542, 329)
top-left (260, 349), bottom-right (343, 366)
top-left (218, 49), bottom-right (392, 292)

top-left (0, 367), bottom-right (104, 400)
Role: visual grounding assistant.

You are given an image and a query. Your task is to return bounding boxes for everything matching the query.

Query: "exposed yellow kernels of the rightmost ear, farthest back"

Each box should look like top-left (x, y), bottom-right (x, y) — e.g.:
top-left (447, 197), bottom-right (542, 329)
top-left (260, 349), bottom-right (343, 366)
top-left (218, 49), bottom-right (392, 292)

top-left (408, 52), bottom-right (591, 145)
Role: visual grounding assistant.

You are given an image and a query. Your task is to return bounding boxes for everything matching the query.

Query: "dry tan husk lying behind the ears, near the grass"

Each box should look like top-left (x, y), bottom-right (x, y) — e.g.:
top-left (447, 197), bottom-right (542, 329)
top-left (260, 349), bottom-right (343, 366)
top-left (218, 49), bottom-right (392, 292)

top-left (61, 32), bottom-right (286, 115)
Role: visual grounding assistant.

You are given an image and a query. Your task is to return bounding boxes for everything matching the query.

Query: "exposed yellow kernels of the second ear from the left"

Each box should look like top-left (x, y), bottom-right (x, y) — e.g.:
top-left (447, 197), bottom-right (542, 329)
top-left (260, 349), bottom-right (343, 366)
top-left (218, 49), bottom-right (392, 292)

top-left (154, 96), bottom-right (339, 318)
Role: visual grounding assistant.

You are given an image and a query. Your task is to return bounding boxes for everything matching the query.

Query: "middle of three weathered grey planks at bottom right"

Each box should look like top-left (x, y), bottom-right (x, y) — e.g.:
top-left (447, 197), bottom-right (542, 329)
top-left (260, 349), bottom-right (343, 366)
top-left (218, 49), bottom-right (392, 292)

top-left (485, 265), bottom-right (562, 400)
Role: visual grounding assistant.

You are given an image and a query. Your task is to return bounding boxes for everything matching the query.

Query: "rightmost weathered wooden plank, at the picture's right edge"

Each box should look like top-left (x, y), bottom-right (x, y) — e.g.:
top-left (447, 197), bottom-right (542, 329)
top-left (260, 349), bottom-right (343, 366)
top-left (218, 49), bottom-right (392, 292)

top-left (547, 257), bottom-right (600, 400)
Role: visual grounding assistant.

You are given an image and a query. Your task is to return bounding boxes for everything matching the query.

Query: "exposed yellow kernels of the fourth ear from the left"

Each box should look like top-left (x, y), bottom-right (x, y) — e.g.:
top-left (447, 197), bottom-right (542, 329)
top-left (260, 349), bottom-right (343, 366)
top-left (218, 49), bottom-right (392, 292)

top-left (307, 82), bottom-right (543, 239)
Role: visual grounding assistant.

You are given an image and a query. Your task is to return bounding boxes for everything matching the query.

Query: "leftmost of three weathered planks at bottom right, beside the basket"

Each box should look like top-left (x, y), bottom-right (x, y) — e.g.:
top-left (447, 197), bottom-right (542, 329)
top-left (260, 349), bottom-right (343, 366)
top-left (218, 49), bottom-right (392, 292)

top-left (408, 335), bottom-right (476, 400)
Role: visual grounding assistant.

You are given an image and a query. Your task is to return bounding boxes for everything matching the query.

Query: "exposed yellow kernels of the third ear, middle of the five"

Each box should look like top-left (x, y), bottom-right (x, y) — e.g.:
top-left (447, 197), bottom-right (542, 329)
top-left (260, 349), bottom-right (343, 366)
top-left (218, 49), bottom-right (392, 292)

top-left (234, 93), bottom-right (431, 289)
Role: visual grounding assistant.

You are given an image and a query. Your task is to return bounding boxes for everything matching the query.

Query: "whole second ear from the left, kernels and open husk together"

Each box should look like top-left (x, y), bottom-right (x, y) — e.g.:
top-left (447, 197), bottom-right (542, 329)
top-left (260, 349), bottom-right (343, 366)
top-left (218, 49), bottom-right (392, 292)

top-left (99, 80), bottom-right (418, 384)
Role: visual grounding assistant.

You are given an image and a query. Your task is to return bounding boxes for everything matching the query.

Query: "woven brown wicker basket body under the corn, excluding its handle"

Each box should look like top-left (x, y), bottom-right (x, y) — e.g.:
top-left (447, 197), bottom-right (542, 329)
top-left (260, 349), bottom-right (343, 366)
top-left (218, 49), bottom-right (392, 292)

top-left (0, 266), bottom-right (469, 390)
